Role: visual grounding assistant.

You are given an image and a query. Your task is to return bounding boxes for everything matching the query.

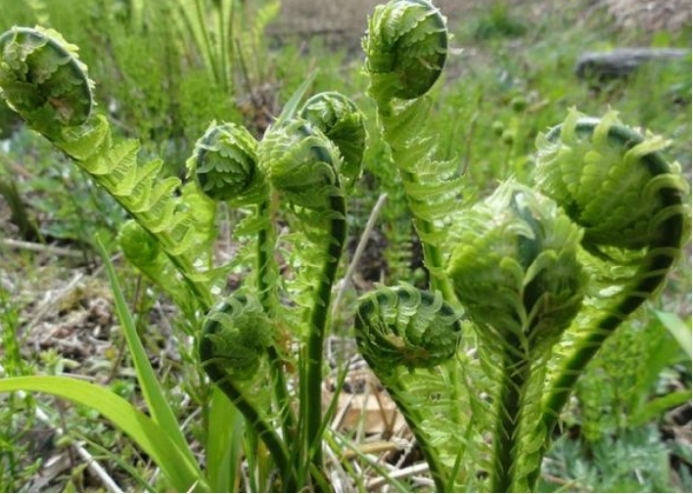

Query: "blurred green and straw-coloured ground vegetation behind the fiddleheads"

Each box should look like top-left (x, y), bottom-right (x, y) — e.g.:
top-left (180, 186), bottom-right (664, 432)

top-left (0, 0), bottom-right (691, 492)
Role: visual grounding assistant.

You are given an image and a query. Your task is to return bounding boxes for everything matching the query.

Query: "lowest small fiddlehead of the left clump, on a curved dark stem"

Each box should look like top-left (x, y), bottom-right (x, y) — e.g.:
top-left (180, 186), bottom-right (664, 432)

top-left (199, 294), bottom-right (295, 489)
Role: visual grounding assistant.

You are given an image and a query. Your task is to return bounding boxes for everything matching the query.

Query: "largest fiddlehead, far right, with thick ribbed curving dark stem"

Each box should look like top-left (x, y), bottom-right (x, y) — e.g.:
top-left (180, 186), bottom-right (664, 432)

top-left (534, 110), bottom-right (687, 486)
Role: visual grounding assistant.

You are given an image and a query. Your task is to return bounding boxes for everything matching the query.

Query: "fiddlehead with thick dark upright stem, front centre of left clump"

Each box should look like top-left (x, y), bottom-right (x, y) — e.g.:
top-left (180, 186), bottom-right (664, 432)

top-left (258, 118), bottom-right (354, 470)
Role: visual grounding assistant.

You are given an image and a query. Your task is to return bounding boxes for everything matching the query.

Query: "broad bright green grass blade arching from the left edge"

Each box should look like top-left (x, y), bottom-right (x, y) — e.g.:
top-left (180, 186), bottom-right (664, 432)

top-left (0, 376), bottom-right (209, 492)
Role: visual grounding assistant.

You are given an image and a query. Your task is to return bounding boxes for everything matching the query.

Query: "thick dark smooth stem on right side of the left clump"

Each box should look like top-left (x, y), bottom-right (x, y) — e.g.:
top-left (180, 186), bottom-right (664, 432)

top-left (301, 194), bottom-right (347, 471)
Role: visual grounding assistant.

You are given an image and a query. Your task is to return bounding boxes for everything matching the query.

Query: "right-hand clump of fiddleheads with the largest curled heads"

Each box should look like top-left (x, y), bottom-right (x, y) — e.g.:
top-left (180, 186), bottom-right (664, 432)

top-left (356, 0), bottom-right (687, 492)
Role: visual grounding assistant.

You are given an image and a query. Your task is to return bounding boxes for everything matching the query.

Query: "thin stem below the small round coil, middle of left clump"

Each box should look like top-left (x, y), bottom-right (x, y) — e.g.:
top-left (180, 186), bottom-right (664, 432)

top-left (257, 201), bottom-right (294, 439)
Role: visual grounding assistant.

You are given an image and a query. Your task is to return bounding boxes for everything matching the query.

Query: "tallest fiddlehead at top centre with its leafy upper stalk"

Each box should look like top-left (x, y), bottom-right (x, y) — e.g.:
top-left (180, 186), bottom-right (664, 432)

top-left (363, 0), bottom-right (461, 302)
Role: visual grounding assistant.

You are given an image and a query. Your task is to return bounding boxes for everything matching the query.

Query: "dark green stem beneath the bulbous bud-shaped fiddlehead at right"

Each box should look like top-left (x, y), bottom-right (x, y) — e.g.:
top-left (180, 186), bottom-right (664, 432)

top-left (491, 341), bottom-right (532, 492)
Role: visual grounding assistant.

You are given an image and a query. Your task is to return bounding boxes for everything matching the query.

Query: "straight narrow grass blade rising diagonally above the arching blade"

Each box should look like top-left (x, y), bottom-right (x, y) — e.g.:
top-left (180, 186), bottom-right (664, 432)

top-left (96, 235), bottom-right (201, 475)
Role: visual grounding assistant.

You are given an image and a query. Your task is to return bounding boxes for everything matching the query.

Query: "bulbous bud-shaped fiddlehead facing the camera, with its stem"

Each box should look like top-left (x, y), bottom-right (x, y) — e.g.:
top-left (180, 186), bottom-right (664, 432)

top-left (447, 182), bottom-right (585, 492)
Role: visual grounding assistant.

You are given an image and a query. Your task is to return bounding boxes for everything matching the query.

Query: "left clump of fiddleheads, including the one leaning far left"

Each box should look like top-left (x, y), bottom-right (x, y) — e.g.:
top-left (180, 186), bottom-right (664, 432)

top-left (0, 22), bottom-right (366, 491)
